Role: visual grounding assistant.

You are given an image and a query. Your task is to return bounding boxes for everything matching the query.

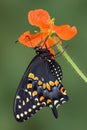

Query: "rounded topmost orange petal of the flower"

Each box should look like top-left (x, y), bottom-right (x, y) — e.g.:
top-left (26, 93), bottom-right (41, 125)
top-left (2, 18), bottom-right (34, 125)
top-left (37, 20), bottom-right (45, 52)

top-left (28, 9), bottom-right (50, 28)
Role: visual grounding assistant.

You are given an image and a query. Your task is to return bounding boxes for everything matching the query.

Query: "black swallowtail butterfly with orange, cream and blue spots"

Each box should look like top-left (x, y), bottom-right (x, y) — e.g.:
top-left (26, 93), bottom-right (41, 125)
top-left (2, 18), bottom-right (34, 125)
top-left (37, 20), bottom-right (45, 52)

top-left (14, 47), bottom-right (68, 122)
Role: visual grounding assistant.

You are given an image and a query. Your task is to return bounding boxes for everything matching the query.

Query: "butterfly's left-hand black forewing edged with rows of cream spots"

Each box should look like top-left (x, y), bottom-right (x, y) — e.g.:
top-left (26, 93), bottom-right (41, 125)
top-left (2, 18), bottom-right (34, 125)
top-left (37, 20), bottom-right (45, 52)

top-left (14, 56), bottom-right (47, 122)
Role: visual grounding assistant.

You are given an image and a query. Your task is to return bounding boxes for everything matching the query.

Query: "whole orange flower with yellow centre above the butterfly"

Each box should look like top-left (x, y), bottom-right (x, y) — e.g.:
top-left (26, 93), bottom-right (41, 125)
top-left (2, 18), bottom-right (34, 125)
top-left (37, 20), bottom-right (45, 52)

top-left (18, 9), bottom-right (77, 48)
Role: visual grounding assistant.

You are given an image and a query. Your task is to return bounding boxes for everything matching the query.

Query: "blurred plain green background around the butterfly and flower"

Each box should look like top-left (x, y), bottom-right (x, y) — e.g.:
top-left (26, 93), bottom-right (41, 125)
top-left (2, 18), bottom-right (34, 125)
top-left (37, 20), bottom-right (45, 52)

top-left (0, 0), bottom-right (87, 130)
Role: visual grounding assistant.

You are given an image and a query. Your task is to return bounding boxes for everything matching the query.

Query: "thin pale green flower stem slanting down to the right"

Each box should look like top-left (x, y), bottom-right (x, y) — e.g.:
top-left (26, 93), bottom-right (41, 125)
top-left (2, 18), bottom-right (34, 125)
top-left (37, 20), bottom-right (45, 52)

top-left (57, 44), bottom-right (87, 82)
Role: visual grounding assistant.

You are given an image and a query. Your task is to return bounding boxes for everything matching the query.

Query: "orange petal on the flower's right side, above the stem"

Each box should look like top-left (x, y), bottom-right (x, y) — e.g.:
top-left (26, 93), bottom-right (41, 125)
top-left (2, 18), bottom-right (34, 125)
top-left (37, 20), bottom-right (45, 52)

top-left (53, 25), bottom-right (77, 40)
